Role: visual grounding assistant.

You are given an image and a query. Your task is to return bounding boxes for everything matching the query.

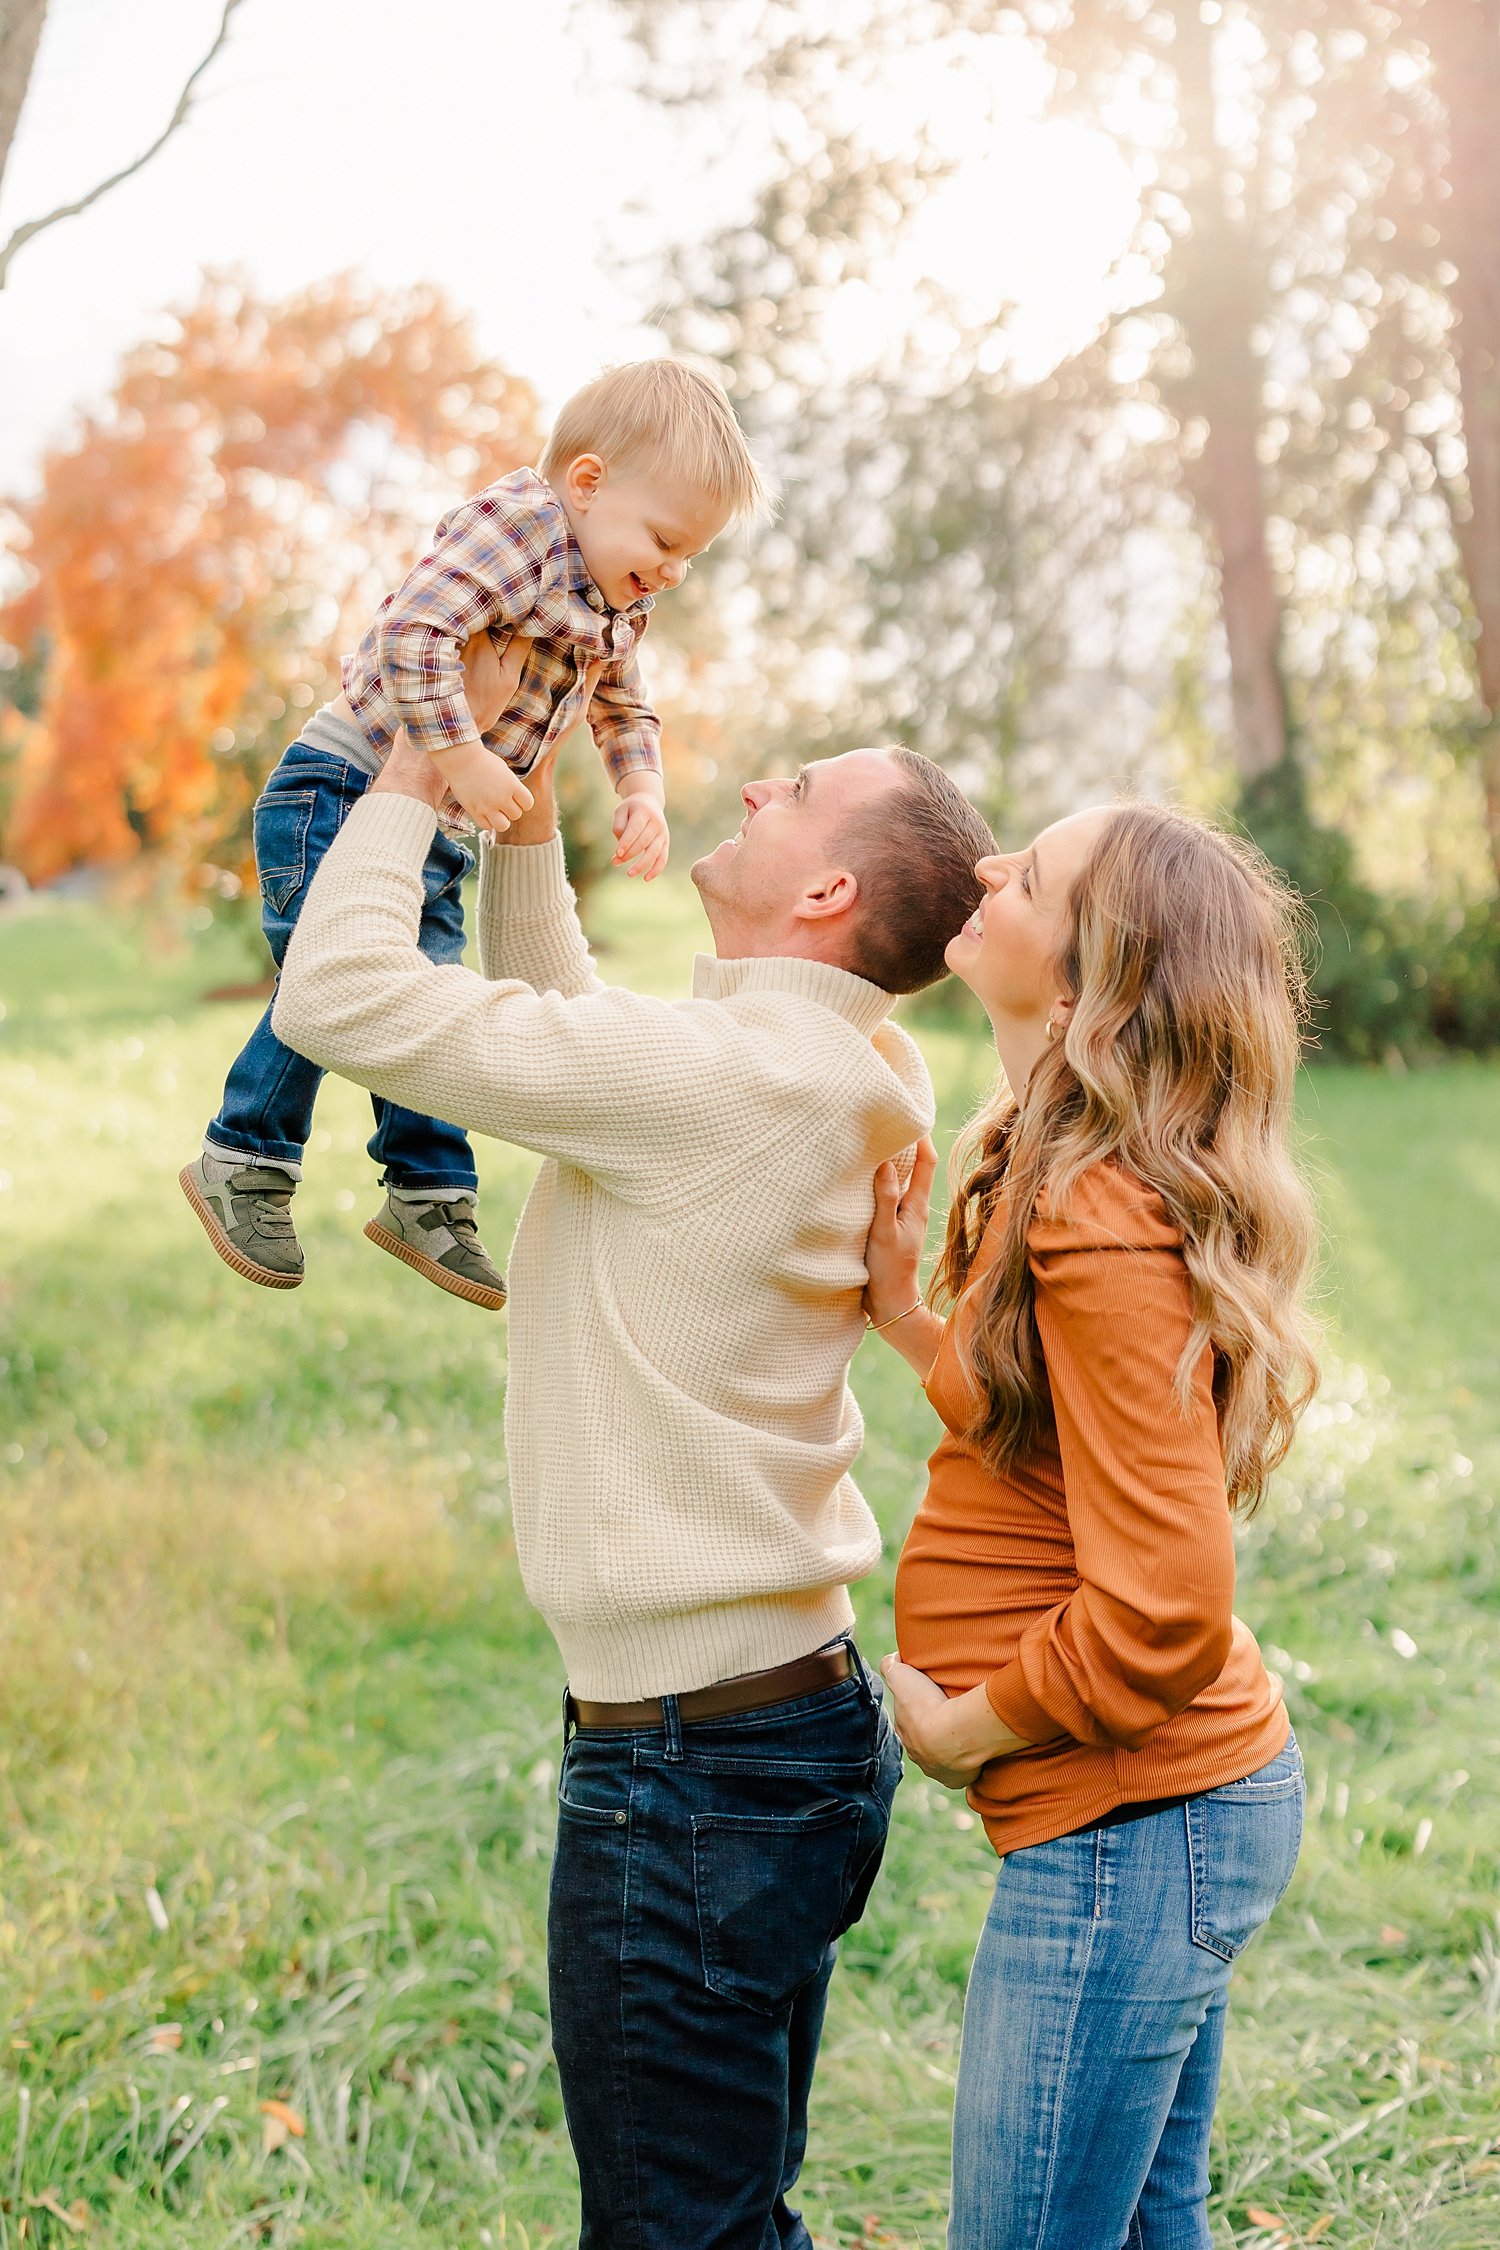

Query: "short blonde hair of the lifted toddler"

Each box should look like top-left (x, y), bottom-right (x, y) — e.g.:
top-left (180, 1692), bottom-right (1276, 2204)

top-left (540, 360), bottom-right (771, 524)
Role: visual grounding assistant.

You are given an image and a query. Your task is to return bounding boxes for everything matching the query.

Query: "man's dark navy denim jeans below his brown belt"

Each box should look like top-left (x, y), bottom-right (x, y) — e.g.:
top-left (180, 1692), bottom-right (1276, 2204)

top-left (546, 1665), bottom-right (902, 2250)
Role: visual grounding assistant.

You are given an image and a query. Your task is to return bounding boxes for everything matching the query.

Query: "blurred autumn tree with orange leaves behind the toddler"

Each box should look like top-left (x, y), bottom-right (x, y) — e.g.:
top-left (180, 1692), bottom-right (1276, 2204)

top-left (0, 277), bottom-right (537, 893)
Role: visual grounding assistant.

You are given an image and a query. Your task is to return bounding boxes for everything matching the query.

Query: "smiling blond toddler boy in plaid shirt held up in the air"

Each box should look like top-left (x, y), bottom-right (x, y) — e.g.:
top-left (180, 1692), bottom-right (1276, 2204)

top-left (180, 360), bottom-right (765, 1312)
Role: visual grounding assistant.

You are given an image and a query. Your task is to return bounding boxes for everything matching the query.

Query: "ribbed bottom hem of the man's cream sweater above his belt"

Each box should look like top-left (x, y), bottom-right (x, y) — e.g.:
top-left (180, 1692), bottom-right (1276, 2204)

top-left (546, 1586), bottom-right (855, 1703)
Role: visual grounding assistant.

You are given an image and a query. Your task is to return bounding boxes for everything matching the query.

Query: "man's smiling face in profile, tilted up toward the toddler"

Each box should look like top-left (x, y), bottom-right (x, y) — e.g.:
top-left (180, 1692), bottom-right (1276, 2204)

top-left (693, 749), bottom-right (902, 961)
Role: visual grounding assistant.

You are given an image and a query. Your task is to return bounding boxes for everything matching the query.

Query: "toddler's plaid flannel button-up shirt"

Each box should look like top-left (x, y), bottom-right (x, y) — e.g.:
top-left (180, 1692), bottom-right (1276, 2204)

top-left (344, 468), bottom-right (661, 788)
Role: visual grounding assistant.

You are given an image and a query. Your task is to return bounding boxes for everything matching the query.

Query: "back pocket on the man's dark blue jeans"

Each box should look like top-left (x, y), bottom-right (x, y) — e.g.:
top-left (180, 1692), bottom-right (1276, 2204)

top-left (693, 1798), bottom-right (861, 2016)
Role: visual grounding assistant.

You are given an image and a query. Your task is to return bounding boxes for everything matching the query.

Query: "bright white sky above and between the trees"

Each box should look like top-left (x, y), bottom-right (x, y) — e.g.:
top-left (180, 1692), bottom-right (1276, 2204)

top-left (0, 0), bottom-right (1133, 491)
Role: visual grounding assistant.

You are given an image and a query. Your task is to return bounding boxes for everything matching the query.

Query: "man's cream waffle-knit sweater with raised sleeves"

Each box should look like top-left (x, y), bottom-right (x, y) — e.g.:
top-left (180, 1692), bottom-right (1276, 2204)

top-left (272, 797), bottom-right (933, 1701)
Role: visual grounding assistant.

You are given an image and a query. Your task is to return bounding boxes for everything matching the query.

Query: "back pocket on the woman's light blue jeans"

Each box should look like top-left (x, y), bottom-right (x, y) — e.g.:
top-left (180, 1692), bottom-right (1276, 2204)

top-left (1183, 1746), bottom-right (1307, 1962)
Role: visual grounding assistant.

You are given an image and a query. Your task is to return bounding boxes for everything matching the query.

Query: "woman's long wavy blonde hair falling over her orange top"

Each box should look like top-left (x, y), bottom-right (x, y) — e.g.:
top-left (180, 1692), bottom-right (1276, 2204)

top-left (936, 806), bottom-right (1318, 1508)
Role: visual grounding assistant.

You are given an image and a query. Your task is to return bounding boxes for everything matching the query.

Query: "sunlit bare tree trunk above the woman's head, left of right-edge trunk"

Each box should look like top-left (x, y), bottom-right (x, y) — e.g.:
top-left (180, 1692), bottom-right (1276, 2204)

top-left (1167, 7), bottom-right (1286, 781)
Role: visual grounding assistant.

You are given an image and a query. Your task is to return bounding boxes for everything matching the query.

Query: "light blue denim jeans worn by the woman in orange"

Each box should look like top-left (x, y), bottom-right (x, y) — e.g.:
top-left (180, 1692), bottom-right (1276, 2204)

top-left (949, 1739), bottom-right (1302, 2250)
